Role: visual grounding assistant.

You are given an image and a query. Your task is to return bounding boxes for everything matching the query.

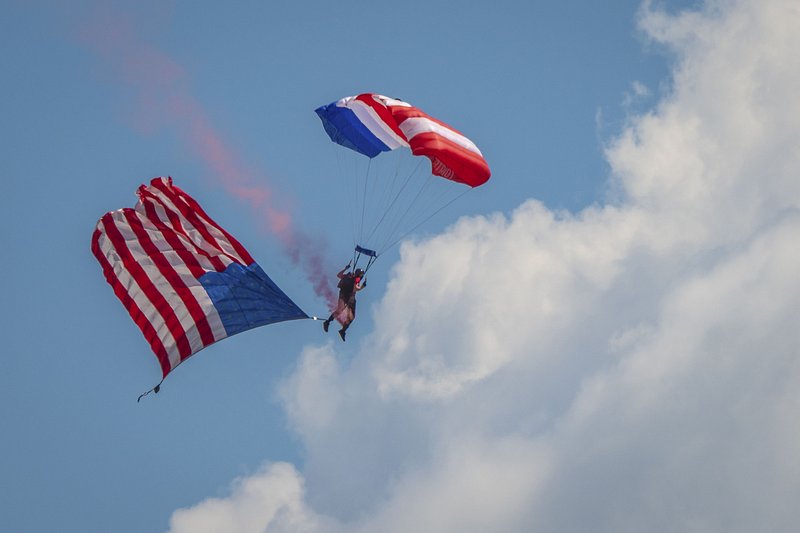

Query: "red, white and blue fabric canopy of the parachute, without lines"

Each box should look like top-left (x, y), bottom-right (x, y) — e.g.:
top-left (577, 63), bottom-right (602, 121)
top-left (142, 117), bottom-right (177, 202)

top-left (316, 93), bottom-right (491, 187)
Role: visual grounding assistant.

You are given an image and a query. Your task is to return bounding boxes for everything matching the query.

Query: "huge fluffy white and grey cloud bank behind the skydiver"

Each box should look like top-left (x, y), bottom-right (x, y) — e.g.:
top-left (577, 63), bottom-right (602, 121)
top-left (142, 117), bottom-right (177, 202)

top-left (172, 0), bottom-right (800, 532)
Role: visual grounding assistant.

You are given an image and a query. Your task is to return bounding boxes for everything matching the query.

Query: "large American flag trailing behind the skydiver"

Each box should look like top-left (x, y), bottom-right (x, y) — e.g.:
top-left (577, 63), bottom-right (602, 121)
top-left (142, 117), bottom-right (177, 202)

top-left (92, 178), bottom-right (308, 377)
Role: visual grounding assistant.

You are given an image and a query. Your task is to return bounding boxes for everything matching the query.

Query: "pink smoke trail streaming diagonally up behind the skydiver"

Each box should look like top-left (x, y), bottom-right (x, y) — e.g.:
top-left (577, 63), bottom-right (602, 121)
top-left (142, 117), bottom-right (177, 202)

top-left (79, 4), bottom-right (336, 307)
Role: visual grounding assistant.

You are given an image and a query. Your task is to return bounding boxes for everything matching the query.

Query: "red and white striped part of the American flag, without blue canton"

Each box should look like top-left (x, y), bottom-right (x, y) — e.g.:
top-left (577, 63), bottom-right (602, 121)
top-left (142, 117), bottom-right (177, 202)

top-left (92, 178), bottom-right (254, 376)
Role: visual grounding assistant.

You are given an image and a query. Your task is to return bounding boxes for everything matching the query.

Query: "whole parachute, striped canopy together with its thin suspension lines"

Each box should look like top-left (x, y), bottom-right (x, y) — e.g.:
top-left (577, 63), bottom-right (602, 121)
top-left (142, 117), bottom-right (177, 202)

top-left (315, 93), bottom-right (491, 267)
